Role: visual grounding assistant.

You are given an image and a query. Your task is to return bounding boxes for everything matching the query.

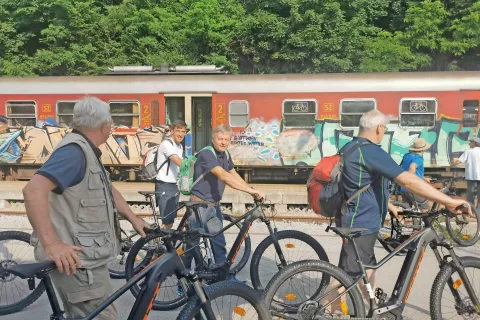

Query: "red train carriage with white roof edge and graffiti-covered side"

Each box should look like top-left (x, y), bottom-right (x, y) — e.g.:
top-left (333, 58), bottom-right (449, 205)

top-left (0, 70), bottom-right (480, 182)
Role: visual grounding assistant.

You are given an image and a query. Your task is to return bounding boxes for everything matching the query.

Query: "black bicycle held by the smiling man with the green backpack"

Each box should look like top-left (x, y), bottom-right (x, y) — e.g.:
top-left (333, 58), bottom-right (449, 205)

top-left (125, 194), bottom-right (329, 310)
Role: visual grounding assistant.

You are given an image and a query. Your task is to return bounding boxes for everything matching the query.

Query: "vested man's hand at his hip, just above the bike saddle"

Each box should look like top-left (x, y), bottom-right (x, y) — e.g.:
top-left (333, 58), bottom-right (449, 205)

top-left (45, 240), bottom-right (83, 276)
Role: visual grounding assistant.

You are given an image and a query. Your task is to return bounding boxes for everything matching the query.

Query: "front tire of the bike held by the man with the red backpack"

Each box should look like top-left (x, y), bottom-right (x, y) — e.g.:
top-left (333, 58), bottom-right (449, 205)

top-left (430, 257), bottom-right (480, 320)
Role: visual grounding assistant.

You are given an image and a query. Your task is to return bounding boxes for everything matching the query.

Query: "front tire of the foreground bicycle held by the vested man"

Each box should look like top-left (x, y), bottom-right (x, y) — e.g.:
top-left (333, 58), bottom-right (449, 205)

top-left (177, 281), bottom-right (271, 320)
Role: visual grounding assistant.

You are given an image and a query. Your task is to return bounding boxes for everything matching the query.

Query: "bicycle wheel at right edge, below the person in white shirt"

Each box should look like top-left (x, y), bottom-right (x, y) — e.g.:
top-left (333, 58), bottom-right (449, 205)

top-left (446, 204), bottom-right (480, 247)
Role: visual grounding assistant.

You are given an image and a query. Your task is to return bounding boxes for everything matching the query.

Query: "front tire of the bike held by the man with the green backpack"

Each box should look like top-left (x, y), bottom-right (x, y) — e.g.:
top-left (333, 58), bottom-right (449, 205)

top-left (250, 230), bottom-right (329, 292)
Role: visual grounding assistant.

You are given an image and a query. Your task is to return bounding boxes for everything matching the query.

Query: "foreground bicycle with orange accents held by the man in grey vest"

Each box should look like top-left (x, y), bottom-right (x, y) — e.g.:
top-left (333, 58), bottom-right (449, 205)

top-left (7, 208), bottom-right (270, 320)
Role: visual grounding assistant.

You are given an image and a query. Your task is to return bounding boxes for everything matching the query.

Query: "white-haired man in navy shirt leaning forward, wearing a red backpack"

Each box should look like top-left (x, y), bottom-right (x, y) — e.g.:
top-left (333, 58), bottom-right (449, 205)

top-left (328, 110), bottom-right (471, 308)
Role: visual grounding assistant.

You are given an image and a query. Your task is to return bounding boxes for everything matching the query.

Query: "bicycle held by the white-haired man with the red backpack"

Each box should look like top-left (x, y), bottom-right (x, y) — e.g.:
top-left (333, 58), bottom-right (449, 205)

top-left (264, 204), bottom-right (480, 320)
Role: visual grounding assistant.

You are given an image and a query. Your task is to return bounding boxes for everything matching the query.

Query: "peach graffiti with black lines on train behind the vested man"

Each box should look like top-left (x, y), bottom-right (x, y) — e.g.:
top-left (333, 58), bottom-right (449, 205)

top-left (0, 115), bottom-right (169, 165)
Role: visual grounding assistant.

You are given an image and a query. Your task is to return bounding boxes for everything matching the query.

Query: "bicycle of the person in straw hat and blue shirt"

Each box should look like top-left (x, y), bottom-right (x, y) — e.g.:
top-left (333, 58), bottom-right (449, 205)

top-left (377, 176), bottom-right (480, 255)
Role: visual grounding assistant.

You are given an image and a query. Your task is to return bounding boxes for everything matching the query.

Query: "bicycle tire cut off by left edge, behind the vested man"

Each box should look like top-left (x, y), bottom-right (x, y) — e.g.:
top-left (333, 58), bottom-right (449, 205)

top-left (0, 231), bottom-right (45, 316)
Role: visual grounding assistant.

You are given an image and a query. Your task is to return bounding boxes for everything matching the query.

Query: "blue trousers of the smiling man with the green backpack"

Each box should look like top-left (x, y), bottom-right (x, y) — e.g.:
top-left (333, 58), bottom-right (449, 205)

top-left (184, 206), bottom-right (227, 268)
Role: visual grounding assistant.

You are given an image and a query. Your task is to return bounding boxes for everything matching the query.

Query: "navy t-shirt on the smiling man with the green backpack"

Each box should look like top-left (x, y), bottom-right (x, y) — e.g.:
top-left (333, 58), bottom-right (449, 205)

top-left (192, 149), bottom-right (233, 202)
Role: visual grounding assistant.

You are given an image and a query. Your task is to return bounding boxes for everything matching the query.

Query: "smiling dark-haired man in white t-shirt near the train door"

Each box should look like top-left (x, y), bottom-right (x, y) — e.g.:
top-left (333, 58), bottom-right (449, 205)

top-left (155, 120), bottom-right (187, 229)
